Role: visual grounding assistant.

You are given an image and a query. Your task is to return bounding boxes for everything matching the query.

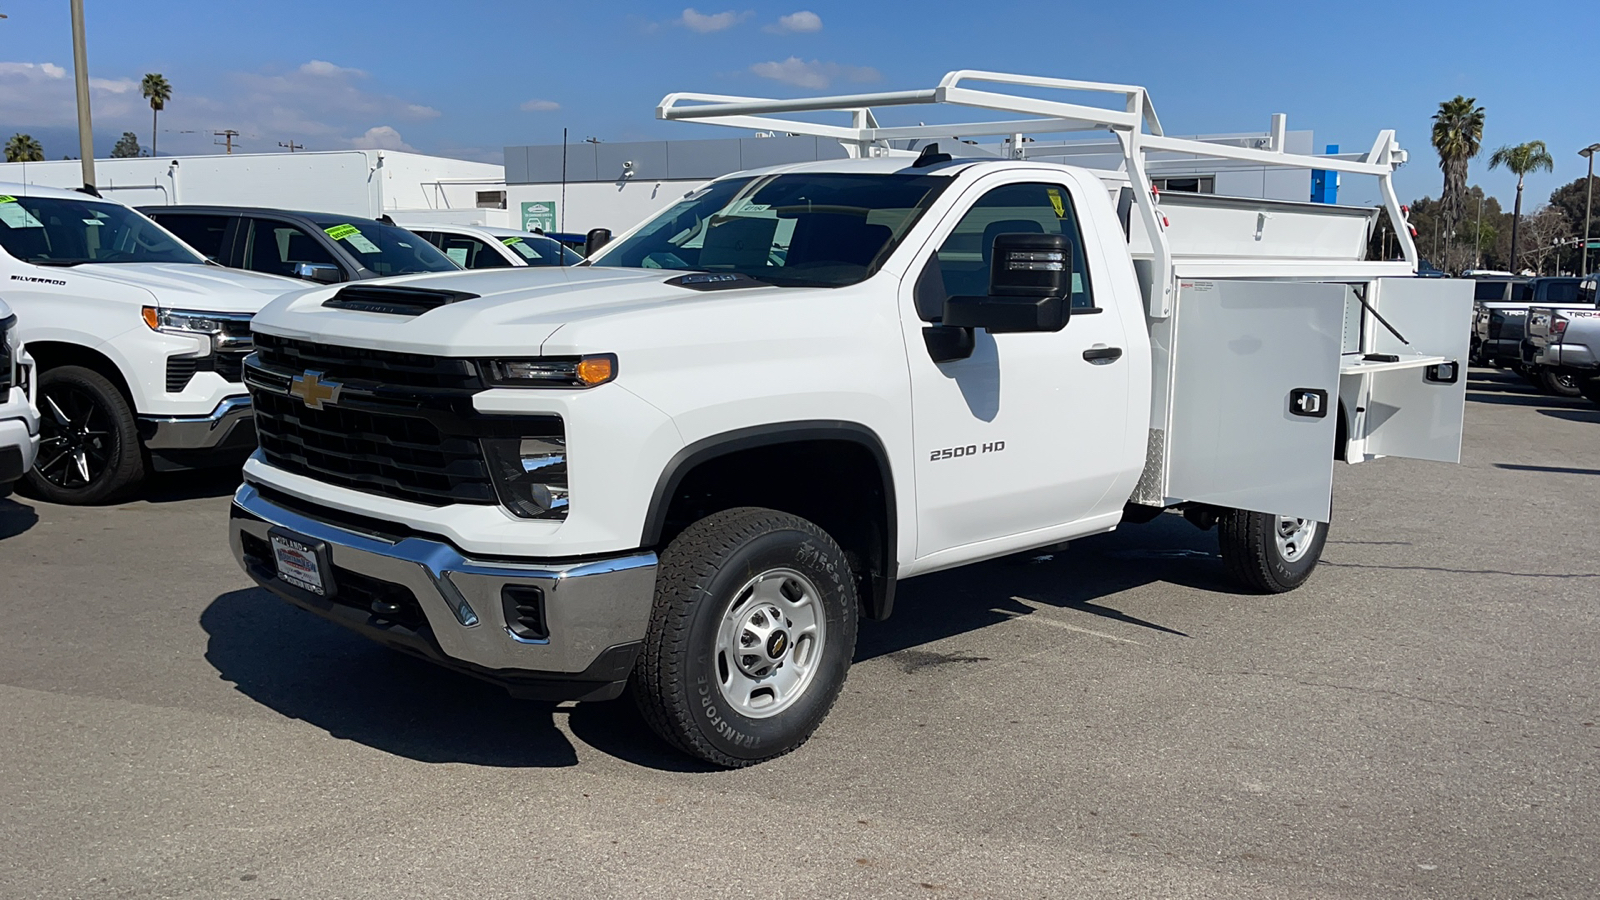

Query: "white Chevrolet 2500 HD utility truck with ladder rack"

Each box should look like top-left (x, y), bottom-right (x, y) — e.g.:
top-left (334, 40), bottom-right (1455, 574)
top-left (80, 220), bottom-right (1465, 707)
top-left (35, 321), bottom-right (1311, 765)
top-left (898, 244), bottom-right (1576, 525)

top-left (230, 72), bottom-right (1472, 767)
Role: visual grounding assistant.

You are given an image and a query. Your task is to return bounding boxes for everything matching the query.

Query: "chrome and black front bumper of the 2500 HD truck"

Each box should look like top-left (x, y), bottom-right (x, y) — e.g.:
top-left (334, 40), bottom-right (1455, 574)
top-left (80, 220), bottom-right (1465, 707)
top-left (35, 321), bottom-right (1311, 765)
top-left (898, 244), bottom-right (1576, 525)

top-left (229, 484), bottom-right (656, 700)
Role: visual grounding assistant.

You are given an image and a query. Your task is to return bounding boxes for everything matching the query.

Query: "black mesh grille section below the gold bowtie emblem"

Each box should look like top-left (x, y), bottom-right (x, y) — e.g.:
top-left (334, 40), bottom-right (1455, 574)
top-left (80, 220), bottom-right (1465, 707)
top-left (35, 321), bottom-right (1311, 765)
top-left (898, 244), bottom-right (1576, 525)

top-left (251, 391), bottom-right (496, 506)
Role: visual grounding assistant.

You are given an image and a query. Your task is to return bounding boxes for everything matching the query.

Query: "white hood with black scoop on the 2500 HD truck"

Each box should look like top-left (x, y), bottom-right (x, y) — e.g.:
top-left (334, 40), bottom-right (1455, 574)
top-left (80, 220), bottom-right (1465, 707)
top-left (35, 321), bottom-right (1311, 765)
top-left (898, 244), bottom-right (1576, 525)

top-left (254, 266), bottom-right (796, 356)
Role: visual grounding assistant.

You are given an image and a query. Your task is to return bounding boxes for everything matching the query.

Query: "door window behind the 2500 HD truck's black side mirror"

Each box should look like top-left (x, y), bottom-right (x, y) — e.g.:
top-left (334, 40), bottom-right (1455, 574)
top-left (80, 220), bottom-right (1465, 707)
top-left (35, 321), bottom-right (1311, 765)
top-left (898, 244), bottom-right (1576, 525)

top-left (918, 183), bottom-right (1094, 322)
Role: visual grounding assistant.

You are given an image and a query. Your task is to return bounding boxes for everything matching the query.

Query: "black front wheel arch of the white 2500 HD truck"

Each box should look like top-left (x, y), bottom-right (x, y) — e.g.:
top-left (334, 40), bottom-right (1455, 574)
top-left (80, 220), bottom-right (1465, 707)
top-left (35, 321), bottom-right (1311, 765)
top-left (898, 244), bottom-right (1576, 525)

top-left (640, 420), bottom-right (898, 620)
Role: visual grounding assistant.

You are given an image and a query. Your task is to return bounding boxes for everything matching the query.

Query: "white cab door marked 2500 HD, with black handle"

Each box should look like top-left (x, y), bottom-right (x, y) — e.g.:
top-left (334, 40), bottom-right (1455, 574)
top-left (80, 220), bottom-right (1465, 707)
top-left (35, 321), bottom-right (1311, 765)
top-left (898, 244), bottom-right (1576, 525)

top-left (901, 173), bottom-right (1144, 559)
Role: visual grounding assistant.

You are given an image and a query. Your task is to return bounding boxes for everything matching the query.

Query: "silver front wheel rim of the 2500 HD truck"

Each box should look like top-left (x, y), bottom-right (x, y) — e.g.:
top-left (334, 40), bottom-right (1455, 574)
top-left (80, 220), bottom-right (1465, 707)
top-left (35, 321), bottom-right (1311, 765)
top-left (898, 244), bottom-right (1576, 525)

top-left (715, 569), bottom-right (827, 719)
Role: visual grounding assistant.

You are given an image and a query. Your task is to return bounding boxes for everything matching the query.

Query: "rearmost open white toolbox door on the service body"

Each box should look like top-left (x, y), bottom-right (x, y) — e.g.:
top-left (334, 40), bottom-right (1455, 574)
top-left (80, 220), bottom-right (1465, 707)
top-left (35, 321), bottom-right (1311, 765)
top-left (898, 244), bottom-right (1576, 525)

top-left (1339, 279), bottom-right (1472, 463)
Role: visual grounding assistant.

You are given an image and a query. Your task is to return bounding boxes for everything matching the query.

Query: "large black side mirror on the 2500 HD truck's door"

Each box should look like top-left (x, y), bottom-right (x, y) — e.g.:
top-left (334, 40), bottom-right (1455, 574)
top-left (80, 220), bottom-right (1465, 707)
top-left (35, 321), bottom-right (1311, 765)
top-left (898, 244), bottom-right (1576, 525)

top-left (944, 234), bottom-right (1072, 335)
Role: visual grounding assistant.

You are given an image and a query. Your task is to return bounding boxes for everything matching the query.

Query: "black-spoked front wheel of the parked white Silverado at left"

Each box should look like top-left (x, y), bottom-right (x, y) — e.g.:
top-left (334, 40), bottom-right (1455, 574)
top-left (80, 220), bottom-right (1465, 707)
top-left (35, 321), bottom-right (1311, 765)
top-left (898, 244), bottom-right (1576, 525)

top-left (24, 365), bottom-right (144, 506)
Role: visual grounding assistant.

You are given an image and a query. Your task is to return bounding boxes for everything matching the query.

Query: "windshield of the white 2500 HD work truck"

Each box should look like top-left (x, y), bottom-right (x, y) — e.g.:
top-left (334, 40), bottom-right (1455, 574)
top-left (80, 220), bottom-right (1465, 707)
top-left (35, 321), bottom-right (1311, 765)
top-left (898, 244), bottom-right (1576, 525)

top-left (592, 173), bottom-right (950, 287)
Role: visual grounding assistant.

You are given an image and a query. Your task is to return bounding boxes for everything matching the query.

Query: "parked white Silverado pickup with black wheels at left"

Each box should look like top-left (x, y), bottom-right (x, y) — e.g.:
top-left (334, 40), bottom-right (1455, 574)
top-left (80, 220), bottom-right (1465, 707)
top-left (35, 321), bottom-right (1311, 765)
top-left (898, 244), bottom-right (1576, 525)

top-left (0, 184), bottom-right (302, 503)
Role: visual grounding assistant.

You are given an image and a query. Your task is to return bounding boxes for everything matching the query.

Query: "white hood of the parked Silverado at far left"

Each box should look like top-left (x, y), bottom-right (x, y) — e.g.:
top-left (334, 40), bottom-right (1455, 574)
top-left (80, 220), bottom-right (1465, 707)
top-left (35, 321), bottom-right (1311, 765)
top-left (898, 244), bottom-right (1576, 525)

top-left (69, 263), bottom-right (306, 312)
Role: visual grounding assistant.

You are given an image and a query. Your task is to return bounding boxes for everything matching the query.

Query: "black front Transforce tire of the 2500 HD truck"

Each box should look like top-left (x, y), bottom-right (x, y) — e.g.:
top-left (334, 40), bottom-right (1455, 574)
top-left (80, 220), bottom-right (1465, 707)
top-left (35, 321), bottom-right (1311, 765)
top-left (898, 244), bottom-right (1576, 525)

top-left (632, 508), bottom-right (858, 769)
